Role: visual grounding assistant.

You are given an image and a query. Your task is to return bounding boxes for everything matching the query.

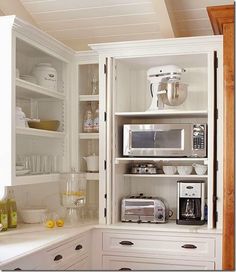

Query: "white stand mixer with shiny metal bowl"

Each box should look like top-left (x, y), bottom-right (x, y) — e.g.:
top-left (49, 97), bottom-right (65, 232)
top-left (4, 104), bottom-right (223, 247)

top-left (147, 65), bottom-right (188, 111)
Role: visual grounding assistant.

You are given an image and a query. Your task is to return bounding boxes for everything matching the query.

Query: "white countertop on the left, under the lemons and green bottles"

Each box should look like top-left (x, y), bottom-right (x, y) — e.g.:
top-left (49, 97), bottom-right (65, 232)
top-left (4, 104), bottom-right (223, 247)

top-left (0, 223), bottom-right (95, 266)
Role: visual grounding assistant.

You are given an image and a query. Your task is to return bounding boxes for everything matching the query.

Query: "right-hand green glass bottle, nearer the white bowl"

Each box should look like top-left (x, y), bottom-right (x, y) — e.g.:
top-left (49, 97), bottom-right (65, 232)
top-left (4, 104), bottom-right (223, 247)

top-left (7, 189), bottom-right (17, 228)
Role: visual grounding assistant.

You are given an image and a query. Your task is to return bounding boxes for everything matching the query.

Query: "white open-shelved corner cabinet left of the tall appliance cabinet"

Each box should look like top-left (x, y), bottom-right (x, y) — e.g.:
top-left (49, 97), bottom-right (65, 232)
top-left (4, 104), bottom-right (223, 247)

top-left (0, 16), bottom-right (105, 225)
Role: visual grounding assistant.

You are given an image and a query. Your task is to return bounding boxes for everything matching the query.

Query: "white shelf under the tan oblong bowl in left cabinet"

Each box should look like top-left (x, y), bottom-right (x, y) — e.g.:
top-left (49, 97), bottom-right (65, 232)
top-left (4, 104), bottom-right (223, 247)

top-left (16, 127), bottom-right (65, 138)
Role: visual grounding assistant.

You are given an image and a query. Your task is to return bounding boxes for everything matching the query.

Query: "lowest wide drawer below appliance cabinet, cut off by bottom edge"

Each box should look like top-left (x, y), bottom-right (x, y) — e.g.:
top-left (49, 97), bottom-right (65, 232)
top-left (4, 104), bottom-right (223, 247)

top-left (102, 256), bottom-right (214, 271)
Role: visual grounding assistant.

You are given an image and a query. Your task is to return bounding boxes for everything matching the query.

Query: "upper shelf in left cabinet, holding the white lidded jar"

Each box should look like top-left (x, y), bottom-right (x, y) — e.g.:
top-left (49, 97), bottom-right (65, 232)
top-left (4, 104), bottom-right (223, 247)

top-left (16, 78), bottom-right (65, 100)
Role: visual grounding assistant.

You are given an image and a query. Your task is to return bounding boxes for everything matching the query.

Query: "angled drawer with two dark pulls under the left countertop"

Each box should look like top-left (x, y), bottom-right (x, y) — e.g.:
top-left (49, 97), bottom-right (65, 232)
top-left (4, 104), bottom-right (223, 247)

top-left (47, 235), bottom-right (89, 269)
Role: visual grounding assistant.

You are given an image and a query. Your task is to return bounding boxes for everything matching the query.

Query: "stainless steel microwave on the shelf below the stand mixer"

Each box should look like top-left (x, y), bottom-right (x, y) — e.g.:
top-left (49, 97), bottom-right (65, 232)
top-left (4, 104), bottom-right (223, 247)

top-left (123, 123), bottom-right (207, 157)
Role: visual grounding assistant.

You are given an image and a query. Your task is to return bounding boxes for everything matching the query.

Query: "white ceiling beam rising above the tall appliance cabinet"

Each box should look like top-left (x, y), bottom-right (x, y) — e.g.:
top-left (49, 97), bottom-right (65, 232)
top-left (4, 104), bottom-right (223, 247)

top-left (152, 0), bottom-right (175, 38)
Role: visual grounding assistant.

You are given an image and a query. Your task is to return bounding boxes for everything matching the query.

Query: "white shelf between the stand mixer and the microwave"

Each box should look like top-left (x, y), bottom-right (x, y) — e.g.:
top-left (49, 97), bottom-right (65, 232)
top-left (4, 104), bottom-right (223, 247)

top-left (115, 110), bottom-right (207, 118)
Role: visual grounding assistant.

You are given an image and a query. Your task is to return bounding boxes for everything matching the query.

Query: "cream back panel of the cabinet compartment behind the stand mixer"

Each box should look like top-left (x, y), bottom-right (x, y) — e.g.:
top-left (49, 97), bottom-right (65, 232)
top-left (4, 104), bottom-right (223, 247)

top-left (114, 57), bottom-right (208, 112)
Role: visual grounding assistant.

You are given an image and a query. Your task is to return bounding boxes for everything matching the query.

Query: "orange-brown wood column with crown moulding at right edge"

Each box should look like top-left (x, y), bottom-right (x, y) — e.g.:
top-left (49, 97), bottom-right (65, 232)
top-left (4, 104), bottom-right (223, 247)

top-left (207, 5), bottom-right (235, 270)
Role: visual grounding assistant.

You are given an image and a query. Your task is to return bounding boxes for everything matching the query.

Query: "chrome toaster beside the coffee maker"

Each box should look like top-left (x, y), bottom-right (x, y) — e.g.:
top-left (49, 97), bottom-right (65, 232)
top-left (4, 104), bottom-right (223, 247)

top-left (121, 194), bottom-right (173, 223)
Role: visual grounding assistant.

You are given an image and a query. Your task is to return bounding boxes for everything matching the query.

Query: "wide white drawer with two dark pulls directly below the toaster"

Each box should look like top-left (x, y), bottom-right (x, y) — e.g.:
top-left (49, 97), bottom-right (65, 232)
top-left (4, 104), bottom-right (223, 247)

top-left (103, 232), bottom-right (215, 260)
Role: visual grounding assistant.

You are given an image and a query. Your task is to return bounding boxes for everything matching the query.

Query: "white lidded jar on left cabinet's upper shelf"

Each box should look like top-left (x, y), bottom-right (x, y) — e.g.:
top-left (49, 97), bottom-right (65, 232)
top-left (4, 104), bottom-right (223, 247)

top-left (32, 63), bottom-right (57, 91)
